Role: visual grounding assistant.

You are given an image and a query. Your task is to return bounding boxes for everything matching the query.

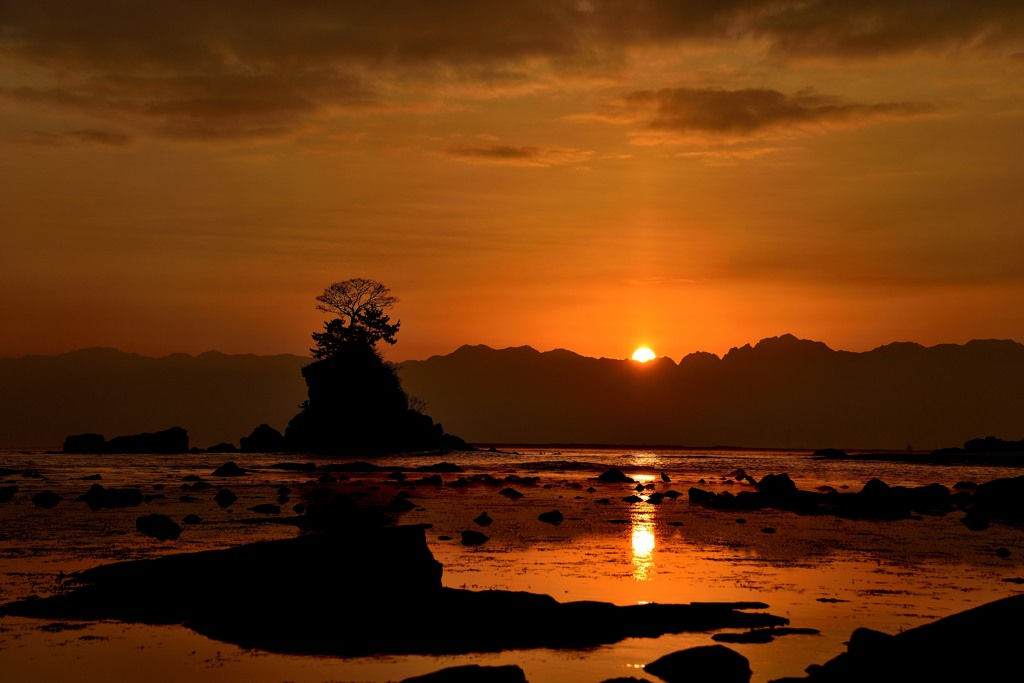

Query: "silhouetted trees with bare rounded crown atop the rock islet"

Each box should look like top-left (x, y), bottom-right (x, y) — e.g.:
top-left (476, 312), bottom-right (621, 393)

top-left (310, 278), bottom-right (401, 360)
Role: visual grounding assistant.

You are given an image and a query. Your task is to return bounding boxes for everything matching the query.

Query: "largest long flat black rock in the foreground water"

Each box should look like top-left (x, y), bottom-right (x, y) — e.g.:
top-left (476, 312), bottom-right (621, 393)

top-left (0, 525), bottom-right (786, 656)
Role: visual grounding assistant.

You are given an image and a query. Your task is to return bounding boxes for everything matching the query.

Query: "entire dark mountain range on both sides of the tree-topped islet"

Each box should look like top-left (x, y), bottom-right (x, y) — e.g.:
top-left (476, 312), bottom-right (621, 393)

top-left (0, 335), bottom-right (1024, 450)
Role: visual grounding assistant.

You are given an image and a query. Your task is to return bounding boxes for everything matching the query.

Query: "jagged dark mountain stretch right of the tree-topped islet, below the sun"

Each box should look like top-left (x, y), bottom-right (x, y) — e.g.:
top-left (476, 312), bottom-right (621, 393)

top-left (401, 335), bottom-right (1024, 450)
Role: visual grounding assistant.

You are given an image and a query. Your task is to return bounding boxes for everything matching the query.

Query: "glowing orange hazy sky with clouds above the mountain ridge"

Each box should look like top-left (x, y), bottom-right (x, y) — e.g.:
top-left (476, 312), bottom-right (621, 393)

top-left (0, 0), bottom-right (1024, 359)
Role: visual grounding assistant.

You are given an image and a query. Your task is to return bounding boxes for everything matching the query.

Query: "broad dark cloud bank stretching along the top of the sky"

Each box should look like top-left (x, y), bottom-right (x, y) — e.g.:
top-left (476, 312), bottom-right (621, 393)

top-left (0, 0), bottom-right (1024, 138)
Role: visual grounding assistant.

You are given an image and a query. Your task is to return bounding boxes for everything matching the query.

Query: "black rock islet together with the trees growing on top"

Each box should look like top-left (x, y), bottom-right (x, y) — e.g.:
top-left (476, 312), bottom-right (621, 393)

top-left (285, 278), bottom-right (468, 455)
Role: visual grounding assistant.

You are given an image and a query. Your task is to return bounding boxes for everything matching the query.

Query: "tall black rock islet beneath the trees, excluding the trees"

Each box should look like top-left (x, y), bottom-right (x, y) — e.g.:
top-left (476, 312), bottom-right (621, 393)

top-left (285, 344), bottom-right (469, 455)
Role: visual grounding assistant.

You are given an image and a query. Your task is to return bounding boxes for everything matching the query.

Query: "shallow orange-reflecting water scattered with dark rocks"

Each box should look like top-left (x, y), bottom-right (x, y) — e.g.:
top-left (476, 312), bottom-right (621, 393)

top-left (0, 447), bottom-right (1024, 683)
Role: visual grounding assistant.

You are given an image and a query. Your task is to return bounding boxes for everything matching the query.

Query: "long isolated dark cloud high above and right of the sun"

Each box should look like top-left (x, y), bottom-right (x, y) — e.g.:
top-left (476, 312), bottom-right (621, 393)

top-left (623, 88), bottom-right (933, 136)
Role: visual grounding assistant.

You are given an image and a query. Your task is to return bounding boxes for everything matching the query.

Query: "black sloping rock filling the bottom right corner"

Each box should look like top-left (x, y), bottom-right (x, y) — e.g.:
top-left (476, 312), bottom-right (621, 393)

top-left (770, 595), bottom-right (1024, 683)
